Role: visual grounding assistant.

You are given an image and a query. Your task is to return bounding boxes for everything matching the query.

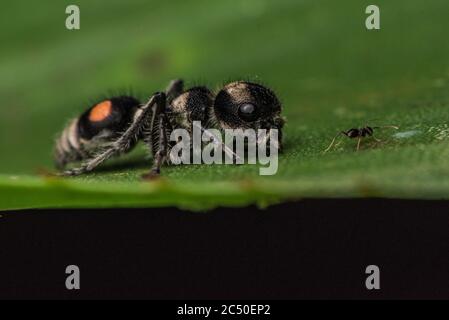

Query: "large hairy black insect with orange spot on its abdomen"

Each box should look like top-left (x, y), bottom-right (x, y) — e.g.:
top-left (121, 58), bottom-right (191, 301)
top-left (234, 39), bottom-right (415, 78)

top-left (55, 79), bottom-right (284, 178)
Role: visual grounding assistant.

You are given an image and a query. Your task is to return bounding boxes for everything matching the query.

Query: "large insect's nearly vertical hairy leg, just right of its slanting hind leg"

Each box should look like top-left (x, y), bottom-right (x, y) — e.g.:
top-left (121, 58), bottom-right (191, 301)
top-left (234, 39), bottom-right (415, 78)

top-left (143, 93), bottom-right (170, 180)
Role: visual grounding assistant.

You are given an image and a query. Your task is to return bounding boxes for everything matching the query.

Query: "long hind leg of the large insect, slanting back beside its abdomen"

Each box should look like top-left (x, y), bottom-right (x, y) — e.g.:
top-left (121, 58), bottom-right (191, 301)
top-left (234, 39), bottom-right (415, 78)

top-left (63, 93), bottom-right (165, 176)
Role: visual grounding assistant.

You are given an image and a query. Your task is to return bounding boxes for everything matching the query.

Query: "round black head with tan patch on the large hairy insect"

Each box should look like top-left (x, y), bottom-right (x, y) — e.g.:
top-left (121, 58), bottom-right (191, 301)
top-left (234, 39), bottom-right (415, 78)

top-left (214, 81), bottom-right (284, 130)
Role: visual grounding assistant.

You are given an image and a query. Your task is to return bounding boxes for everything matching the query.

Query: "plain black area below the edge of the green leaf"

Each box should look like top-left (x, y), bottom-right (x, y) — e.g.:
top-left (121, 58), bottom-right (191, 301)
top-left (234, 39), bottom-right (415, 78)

top-left (0, 199), bottom-right (449, 299)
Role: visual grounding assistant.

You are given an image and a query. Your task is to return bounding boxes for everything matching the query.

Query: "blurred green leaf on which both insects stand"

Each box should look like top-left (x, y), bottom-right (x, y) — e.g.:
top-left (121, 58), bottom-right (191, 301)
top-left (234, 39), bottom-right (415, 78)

top-left (0, 0), bottom-right (449, 208)
